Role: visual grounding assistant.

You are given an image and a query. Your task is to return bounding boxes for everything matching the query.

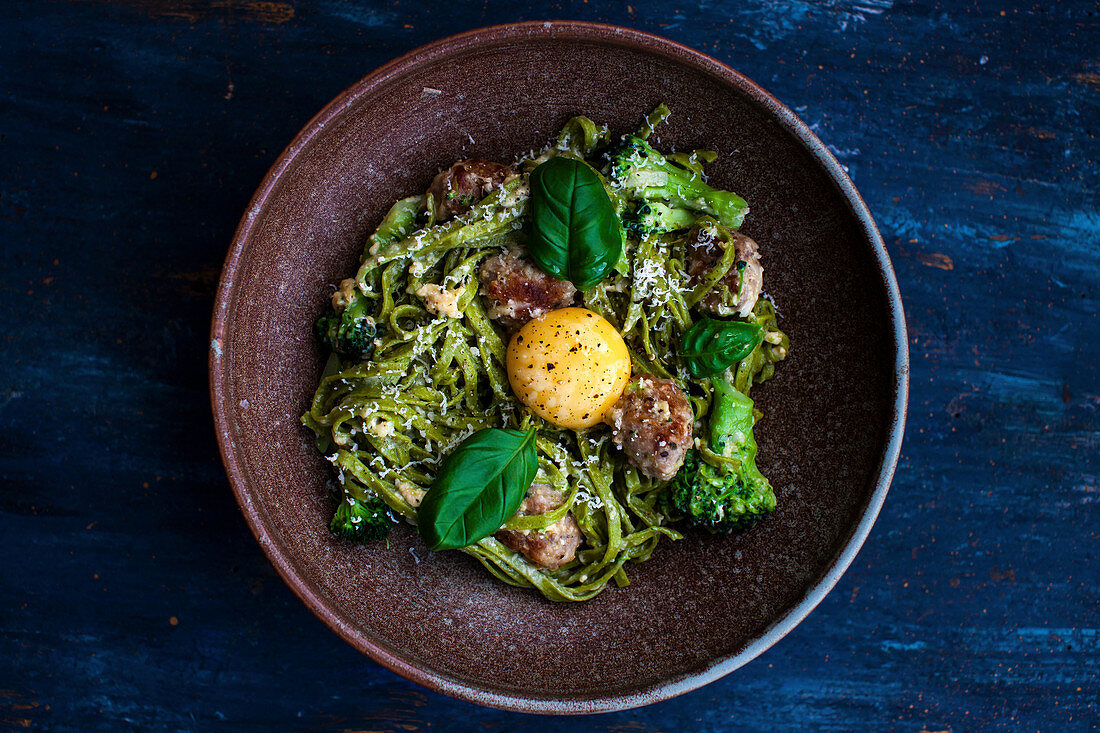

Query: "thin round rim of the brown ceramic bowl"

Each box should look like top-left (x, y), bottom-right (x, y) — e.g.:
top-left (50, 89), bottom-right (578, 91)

top-left (209, 21), bottom-right (910, 714)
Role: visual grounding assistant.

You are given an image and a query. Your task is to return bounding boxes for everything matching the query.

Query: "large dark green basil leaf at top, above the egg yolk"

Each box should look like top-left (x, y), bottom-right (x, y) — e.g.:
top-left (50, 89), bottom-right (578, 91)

top-left (527, 155), bottom-right (623, 291)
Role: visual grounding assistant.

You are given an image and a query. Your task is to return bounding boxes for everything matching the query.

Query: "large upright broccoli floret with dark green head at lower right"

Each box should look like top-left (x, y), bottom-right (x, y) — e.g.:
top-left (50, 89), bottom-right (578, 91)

top-left (667, 372), bottom-right (776, 533)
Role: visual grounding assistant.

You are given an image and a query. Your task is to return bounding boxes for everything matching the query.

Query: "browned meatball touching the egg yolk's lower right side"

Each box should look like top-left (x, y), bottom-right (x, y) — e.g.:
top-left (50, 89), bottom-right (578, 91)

top-left (607, 375), bottom-right (694, 481)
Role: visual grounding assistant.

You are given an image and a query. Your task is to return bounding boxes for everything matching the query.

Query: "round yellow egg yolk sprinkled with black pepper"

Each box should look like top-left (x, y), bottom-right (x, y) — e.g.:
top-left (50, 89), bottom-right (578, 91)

top-left (507, 308), bottom-right (630, 429)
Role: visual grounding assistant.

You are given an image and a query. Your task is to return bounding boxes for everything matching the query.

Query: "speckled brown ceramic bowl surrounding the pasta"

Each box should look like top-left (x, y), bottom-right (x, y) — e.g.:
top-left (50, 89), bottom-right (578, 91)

top-left (210, 22), bottom-right (909, 713)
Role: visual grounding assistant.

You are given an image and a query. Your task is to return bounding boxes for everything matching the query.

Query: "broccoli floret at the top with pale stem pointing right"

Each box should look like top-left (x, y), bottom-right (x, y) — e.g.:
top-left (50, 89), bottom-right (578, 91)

top-left (605, 135), bottom-right (749, 229)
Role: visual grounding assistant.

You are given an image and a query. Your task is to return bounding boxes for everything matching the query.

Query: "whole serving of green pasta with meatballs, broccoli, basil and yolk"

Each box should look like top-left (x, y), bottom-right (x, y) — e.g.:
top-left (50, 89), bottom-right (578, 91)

top-left (301, 105), bottom-right (790, 601)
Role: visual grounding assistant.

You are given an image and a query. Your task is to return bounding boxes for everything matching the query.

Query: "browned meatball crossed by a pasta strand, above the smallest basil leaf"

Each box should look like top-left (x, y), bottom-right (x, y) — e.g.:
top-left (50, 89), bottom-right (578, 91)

top-left (688, 225), bottom-right (763, 318)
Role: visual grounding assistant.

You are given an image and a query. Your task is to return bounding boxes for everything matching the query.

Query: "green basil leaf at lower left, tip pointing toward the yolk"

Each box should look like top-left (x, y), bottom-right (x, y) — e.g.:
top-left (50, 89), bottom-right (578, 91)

top-left (417, 428), bottom-right (539, 550)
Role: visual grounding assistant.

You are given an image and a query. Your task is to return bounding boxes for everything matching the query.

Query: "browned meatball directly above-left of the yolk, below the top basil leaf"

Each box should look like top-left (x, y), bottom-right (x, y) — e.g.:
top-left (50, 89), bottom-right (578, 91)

top-left (477, 249), bottom-right (576, 329)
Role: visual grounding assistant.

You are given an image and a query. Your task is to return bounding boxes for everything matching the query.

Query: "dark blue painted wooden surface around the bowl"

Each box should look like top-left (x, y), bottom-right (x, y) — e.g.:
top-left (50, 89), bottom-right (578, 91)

top-left (0, 0), bottom-right (1100, 732)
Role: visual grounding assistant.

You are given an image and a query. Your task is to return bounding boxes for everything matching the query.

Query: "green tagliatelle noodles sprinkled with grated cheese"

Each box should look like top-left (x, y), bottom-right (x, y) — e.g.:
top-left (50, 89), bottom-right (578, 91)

top-left (301, 111), bottom-right (788, 601)
